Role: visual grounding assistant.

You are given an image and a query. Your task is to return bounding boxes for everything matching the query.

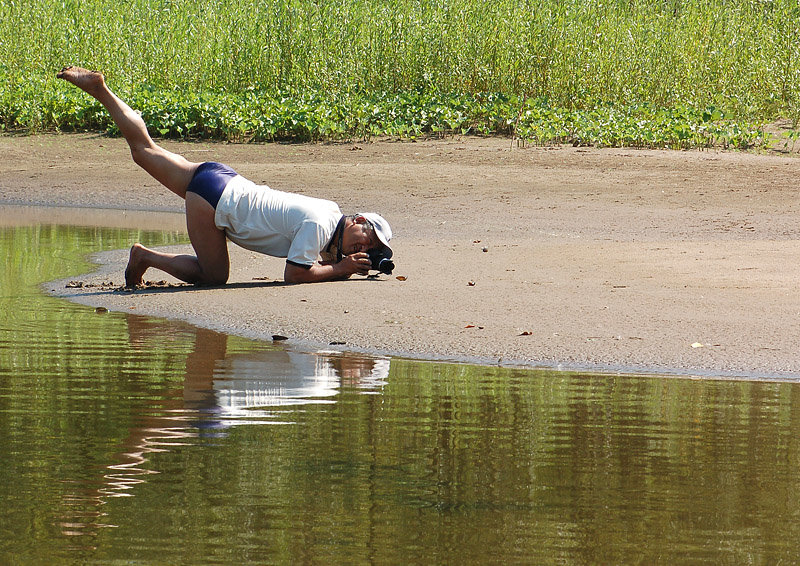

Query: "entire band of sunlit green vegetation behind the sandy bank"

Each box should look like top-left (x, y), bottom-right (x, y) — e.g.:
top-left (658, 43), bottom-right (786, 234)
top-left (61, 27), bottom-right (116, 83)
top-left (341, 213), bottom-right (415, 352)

top-left (0, 0), bottom-right (800, 148)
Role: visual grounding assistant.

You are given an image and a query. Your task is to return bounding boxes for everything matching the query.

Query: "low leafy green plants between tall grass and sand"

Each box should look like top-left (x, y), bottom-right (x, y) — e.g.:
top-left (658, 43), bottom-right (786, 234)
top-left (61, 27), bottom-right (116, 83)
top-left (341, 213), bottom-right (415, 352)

top-left (0, 75), bottom-right (767, 149)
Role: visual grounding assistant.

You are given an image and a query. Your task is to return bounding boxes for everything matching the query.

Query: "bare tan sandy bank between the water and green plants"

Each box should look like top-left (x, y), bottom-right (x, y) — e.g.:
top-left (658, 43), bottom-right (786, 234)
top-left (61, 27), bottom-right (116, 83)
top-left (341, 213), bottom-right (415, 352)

top-left (0, 134), bottom-right (800, 378)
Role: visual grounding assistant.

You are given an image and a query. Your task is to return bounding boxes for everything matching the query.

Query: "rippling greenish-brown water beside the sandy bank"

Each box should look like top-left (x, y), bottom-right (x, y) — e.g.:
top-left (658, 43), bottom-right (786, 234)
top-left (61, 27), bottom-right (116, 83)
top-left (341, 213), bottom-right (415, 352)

top-left (0, 226), bottom-right (800, 564)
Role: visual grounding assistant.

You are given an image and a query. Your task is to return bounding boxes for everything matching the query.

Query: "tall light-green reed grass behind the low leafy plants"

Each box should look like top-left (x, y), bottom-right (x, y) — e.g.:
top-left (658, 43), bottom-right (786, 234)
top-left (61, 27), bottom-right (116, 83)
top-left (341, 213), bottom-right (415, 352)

top-left (0, 0), bottom-right (800, 145)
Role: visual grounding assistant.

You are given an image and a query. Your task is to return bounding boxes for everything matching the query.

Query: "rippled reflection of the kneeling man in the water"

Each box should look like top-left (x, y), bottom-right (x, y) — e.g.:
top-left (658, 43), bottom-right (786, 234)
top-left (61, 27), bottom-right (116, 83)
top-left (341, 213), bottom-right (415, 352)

top-left (76, 314), bottom-right (390, 506)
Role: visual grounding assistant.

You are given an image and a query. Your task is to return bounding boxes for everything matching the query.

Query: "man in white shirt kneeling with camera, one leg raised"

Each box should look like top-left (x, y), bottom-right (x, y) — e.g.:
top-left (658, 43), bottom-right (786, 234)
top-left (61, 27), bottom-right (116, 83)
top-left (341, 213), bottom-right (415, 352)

top-left (56, 67), bottom-right (394, 287)
